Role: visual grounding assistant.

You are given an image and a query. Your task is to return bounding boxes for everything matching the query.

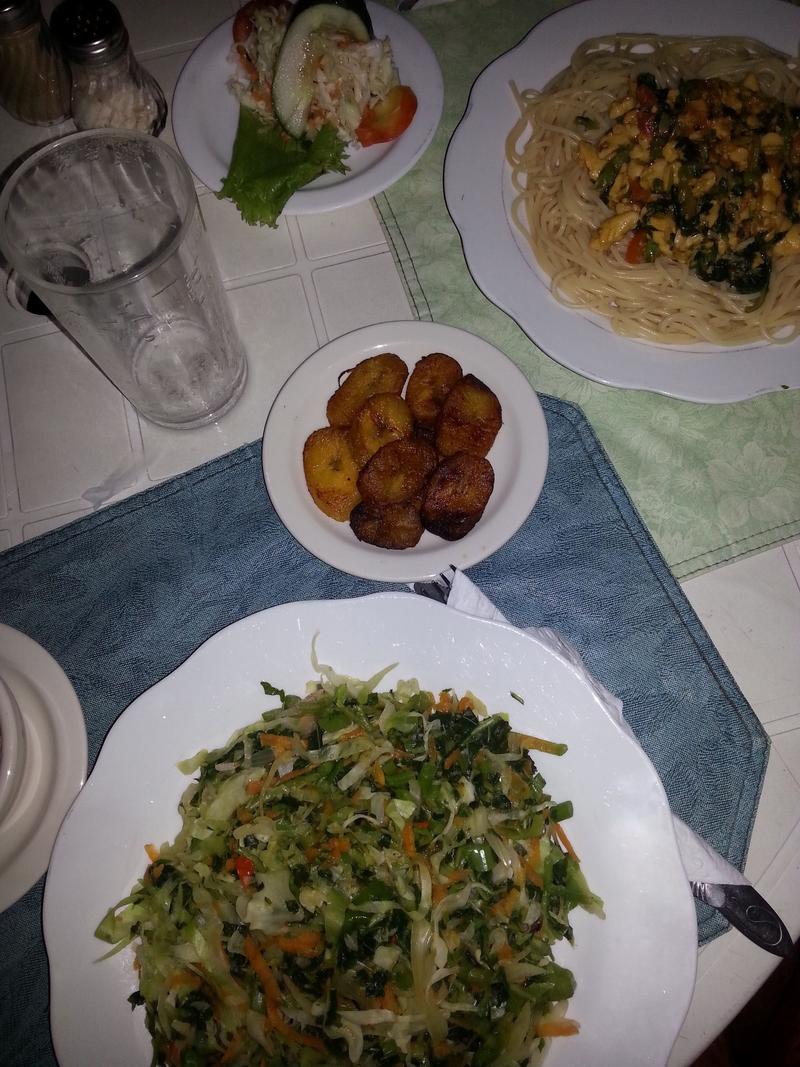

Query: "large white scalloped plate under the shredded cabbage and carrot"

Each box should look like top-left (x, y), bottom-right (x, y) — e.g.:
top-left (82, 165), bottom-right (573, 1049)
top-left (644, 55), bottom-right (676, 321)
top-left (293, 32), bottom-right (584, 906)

top-left (44, 593), bottom-right (697, 1067)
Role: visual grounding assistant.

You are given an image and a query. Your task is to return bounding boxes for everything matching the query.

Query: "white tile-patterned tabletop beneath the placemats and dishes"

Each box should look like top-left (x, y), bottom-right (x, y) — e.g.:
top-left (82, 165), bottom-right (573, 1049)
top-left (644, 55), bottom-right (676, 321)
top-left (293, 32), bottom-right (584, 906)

top-left (0, 0), bottom-right (800, 1067)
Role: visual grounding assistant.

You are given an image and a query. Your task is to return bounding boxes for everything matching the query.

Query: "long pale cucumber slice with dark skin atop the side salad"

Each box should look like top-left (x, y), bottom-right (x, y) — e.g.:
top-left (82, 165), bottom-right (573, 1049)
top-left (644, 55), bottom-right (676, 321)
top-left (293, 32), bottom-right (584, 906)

top-left (272, 0), bottom-right (372, 138)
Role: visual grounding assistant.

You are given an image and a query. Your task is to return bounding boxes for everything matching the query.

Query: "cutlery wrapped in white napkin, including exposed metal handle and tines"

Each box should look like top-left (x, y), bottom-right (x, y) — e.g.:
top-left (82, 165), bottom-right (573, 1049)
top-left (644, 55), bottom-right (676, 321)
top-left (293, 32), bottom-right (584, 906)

top-left (413, 567), bottom-right (794, 956)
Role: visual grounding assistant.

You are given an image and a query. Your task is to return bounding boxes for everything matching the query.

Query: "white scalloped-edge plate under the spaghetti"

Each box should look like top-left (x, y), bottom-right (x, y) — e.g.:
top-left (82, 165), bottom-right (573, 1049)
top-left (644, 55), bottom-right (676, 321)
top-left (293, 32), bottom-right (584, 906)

top-left (445, 0), bottom-right (800, 403)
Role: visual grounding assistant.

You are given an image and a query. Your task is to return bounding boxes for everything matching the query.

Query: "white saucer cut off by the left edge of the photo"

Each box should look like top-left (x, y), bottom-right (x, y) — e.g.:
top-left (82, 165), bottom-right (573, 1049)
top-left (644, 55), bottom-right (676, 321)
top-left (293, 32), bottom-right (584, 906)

top-left (0, 624), bottom-right (86, 911)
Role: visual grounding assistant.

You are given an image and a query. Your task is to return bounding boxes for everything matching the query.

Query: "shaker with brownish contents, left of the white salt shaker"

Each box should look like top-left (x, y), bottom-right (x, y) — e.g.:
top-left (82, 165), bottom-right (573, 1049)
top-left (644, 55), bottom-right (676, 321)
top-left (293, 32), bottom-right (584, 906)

top-left (0, 0), bottom-right (69, 126)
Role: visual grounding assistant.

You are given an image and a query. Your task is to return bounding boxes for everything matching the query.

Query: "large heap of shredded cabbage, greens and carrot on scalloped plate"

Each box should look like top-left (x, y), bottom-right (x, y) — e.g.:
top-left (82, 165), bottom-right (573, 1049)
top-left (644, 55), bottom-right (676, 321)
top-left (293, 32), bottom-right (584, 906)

top-left (96, 658), bottom-right (603, 1067)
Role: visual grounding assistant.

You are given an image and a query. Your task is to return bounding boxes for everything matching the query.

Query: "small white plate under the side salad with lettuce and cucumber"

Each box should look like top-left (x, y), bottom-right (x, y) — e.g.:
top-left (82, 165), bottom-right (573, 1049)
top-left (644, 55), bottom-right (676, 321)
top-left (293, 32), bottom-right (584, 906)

top-left (172, 3), bottom-right (444, 214)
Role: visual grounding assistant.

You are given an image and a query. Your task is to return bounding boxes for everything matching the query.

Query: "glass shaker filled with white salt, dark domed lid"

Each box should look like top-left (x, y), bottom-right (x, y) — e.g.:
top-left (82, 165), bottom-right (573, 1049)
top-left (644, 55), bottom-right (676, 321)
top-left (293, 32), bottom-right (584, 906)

top-left (49, 0), bottom-right (166, 137)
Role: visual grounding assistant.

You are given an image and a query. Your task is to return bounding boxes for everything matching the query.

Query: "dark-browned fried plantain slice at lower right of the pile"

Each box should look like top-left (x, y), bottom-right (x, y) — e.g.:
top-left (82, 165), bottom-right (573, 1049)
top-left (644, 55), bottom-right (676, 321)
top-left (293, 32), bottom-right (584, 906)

top-left (420, 452), bottom-right (495, 541)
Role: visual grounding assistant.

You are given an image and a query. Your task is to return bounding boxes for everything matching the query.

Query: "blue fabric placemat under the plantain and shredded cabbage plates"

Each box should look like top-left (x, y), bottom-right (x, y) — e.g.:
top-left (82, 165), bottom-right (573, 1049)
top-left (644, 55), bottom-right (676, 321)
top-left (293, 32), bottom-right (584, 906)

top-left (0, 397), bottom-right (768, 1067)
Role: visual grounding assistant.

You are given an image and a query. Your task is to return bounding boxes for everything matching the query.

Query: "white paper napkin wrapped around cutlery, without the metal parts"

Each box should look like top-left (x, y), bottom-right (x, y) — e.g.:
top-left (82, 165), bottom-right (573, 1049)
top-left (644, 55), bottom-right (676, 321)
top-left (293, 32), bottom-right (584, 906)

top-left (447, 571), bottom-right (750, 886)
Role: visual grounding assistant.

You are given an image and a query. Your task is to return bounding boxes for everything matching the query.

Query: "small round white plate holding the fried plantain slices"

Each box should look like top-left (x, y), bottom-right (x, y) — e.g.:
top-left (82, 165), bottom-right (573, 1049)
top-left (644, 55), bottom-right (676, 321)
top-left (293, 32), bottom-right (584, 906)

top-left (262, 320), bottom-right (548, 582)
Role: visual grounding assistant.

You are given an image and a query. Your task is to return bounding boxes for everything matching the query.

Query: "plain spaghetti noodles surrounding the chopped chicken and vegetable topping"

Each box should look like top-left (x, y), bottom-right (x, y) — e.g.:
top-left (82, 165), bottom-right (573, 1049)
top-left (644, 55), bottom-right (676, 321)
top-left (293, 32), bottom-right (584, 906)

top-left (506, 34), bottom-right (800, 346)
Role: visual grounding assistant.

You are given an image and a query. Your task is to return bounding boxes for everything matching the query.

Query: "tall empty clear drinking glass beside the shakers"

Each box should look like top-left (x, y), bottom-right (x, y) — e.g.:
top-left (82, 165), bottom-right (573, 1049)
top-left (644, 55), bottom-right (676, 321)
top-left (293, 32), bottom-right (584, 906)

top-left (0, 129), bottom-right (246, 428)
